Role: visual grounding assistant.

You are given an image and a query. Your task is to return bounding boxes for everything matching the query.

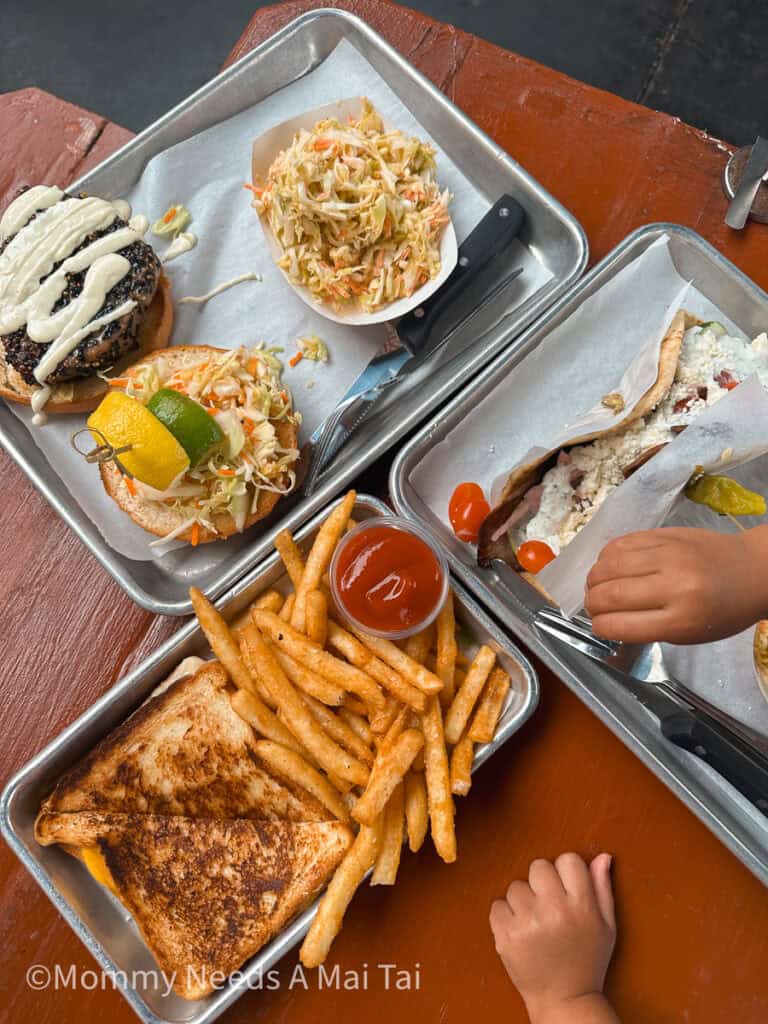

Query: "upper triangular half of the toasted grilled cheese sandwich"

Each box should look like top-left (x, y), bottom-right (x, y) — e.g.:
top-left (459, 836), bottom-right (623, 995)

top-left (34, 662), bottom-right (332, 821)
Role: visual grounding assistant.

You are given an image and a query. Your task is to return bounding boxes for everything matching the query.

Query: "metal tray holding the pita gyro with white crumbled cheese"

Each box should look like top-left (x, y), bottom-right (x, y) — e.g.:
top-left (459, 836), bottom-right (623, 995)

top-left (389, 224), bottom-right (768, 885)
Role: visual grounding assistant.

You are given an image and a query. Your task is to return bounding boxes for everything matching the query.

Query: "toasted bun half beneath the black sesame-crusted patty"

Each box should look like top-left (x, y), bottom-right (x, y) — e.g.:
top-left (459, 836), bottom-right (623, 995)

top-left (0, 273), bottom-right (173, 414)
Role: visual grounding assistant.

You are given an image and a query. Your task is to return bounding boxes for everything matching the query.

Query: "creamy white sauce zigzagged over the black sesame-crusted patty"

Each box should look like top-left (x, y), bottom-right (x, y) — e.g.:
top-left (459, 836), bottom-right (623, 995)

top-left (0, 185), bottom-right (143, 401)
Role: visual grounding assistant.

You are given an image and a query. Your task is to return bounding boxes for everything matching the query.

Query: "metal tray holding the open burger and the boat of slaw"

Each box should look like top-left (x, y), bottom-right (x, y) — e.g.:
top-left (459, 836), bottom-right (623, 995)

top-left (0, 10), bottom-right (587, 615)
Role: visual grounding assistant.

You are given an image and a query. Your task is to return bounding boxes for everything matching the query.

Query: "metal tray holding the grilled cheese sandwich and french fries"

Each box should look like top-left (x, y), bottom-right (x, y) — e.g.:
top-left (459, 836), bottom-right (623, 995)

top-left (0, 495), bottom-right (539, 1024)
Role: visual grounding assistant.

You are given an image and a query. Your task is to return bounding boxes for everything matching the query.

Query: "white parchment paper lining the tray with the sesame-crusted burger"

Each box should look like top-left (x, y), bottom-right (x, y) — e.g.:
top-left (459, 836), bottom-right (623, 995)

top-left (12, 40), bottom-right (552, 575)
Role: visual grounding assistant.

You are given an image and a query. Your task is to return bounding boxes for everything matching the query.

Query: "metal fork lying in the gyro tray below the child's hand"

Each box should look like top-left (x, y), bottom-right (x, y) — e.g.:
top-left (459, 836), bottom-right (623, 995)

top-left (534, 608), bottom-right (768, 764)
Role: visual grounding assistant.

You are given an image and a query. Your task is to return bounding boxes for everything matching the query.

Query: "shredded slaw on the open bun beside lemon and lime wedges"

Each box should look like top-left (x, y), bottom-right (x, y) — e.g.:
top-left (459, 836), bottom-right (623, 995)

top-left (111, 344), bottom-right (301, 546)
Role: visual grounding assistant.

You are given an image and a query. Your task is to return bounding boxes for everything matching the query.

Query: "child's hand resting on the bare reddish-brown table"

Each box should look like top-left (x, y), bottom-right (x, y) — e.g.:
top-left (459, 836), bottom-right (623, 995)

top-left (490, 853), bottom-right (616, 1022)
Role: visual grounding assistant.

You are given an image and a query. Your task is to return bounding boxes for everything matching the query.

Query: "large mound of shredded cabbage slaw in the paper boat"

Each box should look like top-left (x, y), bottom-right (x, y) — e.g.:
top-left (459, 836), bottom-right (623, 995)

top-left (248, 99), bottom-right (451, 312)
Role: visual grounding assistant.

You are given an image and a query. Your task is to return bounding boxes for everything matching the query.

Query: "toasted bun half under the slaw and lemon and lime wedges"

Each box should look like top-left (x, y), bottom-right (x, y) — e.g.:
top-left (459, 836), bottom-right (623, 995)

top-left (99, 345), bottom-right (299, 544)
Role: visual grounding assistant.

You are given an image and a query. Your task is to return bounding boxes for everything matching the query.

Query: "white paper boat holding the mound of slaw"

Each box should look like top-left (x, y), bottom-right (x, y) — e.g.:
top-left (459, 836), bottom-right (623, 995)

top-left (251, 96), bottom-right (458, 327)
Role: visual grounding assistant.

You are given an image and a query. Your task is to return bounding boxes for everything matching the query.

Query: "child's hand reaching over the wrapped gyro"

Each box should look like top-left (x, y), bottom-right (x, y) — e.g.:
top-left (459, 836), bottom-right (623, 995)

top-left (584, 526), bottom-right (768, 643)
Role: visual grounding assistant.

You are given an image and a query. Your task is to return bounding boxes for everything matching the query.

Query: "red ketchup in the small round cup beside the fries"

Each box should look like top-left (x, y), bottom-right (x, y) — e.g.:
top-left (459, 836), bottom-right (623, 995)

top-left (334, 526), bottom-right (443, 633)
